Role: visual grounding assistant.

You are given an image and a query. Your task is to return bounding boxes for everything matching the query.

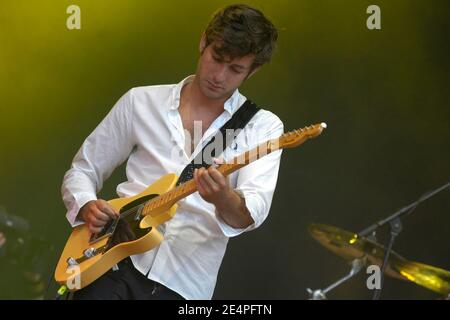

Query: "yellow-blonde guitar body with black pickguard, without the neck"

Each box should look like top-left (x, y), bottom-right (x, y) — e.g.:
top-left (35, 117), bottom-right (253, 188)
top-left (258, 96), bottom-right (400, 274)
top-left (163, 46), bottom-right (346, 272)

top-left (55, 174), bottom-right (178, 290)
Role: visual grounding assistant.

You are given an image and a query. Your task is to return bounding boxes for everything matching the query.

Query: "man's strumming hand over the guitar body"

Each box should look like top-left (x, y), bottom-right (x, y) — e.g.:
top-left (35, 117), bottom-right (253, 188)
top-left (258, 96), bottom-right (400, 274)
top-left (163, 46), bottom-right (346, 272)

top-left (78, 199), bottom-right (119, 233)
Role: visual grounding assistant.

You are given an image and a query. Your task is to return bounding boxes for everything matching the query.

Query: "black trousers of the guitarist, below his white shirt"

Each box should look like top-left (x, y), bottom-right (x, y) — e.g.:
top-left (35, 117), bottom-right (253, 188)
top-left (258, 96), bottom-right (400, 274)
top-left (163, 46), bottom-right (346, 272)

top-left (73, 258), bottom-right (184, 300)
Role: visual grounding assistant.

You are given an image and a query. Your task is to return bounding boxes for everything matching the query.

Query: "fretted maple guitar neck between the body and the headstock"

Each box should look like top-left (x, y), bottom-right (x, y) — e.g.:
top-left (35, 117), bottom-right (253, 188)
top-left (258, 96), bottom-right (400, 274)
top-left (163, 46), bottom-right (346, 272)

top-left (142, 139), bottom-right (280, 215)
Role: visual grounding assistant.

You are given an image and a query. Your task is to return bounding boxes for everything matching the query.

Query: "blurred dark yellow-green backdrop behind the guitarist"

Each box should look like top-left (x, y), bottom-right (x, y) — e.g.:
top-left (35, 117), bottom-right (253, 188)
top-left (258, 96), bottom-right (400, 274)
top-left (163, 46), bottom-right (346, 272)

top-left (0, 0), bottom-right (450, 299)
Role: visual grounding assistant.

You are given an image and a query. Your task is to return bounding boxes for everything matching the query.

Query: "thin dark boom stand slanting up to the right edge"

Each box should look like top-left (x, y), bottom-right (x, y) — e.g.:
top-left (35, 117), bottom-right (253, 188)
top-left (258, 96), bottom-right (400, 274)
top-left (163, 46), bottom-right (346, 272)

top-left (358, 182), bottom-right (450, 300)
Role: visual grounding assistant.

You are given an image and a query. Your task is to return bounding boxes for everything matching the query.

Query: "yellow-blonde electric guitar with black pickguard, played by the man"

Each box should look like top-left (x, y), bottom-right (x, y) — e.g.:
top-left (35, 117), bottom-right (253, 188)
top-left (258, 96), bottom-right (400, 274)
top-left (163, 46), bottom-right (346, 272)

top-left (55, 123), bottom-right (326, 291)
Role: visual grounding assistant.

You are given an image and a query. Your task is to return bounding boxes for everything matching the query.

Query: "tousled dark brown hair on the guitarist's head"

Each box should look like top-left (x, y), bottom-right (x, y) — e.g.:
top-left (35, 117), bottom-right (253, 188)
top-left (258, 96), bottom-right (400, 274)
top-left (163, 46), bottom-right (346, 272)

top-left (205, 4), bottom-right (278, 70)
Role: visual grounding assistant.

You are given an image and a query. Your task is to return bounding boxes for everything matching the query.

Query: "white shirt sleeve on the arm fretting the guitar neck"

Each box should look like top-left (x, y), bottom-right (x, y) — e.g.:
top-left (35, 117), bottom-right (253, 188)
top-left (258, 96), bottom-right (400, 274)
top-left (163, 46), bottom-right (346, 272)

top-left (216, 113), bottom-right (284, 237)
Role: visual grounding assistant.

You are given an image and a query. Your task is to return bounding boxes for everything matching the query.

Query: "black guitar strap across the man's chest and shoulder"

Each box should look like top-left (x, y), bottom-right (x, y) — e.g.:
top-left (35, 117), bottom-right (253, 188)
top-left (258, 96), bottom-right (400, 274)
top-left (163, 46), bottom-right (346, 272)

top-left (177, 99), bottom-right (260, 186)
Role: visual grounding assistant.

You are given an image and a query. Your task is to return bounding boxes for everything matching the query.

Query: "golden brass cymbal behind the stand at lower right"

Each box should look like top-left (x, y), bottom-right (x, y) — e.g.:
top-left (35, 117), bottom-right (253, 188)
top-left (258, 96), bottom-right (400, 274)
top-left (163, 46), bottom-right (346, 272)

top-left (308, 224), bottom-right (450, 294)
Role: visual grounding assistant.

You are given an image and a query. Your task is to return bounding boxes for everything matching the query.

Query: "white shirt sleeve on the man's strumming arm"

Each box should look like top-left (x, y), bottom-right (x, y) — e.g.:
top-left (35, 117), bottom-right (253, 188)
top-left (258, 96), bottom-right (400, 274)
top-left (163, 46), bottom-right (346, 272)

top-left (61, 90), bottom-right (135, 227)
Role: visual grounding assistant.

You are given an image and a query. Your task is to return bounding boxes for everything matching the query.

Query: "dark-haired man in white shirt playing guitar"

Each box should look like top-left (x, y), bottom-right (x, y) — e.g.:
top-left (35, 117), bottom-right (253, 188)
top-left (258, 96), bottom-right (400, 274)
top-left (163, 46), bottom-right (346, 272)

top-left (62, 5), bottom-right (283, 299)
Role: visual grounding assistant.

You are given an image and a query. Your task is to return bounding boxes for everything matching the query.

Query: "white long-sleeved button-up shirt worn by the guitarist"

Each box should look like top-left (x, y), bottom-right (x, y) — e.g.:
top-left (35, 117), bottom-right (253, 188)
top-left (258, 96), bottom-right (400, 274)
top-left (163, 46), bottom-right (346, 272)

top-left (61, 76), bottom-right (283, 299)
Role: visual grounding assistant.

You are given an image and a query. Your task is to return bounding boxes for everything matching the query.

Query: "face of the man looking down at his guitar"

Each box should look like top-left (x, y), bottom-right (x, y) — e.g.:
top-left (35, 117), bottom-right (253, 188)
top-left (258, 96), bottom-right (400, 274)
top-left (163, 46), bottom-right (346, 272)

top-left (196, 38), bottom-right (257, 99)
